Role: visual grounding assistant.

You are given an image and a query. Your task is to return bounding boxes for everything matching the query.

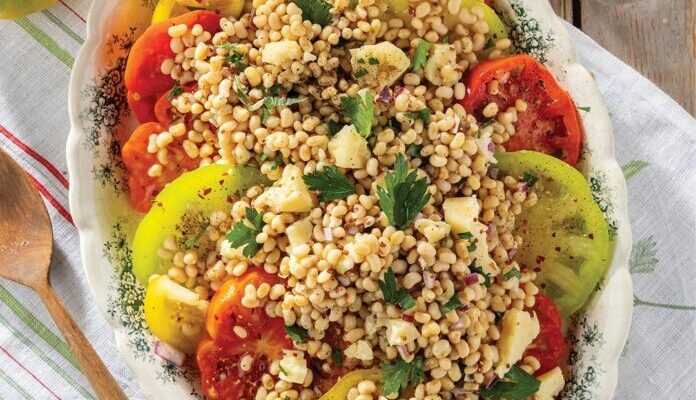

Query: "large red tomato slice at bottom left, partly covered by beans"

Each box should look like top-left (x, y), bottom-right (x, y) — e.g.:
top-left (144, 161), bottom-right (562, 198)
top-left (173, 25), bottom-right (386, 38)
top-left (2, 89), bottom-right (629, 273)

top-left (196, 269), bottom-right (292, 400)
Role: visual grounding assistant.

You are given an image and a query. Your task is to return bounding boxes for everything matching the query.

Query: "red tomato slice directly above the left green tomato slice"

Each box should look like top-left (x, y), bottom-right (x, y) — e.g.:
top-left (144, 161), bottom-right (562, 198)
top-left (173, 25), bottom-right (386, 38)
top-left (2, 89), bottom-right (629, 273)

top-left (121, 122), bottom-right (198, 212)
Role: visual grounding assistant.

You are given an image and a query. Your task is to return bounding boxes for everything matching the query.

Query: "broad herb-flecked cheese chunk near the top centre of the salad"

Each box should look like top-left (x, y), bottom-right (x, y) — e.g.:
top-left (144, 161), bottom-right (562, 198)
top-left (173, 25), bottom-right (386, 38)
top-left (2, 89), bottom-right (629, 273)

top-left (350, 42), bottom-right (411, 90)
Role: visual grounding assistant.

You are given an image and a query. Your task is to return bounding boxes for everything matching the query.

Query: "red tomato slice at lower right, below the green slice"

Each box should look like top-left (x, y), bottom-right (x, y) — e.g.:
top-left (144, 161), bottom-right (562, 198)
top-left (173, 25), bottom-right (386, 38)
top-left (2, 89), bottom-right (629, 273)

top-left (524, 294), bottom-right (565, 376)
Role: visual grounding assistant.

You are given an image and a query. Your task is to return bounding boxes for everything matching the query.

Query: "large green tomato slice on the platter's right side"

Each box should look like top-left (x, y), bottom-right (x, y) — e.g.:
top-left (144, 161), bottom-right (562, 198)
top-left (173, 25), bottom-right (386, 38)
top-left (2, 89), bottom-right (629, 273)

top-left (495, 151), bottom-right (609, 318)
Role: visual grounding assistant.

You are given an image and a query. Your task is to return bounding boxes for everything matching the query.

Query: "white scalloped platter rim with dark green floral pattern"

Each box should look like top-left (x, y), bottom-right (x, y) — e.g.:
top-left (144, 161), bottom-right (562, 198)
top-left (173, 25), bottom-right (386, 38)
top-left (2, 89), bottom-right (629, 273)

top-left (67, 0), bottom-right (633, 400)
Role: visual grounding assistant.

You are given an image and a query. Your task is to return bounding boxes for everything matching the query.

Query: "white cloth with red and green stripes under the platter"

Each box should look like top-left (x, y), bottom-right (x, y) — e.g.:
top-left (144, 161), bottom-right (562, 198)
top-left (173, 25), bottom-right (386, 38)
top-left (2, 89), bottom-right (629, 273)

top-left (0, 0), bottom-right (696, 400)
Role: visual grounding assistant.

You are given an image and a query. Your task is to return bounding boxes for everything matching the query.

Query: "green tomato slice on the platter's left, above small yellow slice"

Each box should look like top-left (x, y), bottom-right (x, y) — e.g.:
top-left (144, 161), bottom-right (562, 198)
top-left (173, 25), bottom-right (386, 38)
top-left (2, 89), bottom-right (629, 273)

top-left (133, 165), bottom-right (266, 285)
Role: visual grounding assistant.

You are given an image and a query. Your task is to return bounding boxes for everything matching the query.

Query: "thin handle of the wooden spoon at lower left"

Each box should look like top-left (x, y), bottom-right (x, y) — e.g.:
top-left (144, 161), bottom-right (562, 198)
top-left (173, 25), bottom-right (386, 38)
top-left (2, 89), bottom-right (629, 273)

top-left (35, 282), bottom-right (127, 400)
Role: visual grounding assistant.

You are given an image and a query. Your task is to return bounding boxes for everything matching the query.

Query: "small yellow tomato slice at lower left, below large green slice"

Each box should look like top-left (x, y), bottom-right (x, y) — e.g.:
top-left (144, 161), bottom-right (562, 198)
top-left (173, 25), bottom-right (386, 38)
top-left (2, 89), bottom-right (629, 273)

top-left (143, 275), bottom-right (208, 354)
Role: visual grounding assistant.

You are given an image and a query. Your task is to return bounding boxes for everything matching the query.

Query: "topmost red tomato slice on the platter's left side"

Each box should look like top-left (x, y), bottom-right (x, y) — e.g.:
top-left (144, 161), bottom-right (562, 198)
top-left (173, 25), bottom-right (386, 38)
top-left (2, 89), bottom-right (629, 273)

top-left (124, 10), bottom-right (222, 123)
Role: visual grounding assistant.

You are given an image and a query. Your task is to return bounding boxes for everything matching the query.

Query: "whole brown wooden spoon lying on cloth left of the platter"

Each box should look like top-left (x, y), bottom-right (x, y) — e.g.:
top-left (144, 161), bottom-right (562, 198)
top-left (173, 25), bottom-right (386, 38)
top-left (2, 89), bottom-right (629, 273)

top-left (0, 150), bottom-right (127, 400)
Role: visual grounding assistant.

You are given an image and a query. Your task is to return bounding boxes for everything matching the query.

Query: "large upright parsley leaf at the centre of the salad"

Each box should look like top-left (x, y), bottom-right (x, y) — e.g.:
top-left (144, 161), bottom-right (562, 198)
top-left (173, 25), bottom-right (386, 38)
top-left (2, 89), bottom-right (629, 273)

top-left (377, 154), bottom-right (430, 229)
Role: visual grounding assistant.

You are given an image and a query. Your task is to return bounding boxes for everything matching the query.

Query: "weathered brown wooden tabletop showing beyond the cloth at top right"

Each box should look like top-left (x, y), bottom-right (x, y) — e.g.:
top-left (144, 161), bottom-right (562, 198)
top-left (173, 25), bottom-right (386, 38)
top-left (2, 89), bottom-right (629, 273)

top-left (550, 0), bottom-right (696, 115)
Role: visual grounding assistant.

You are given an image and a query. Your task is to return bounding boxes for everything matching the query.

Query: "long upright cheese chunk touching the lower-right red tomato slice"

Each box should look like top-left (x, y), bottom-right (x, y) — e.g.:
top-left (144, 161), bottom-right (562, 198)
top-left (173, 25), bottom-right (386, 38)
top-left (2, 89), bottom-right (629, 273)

top-left (495, 308), bottom-right (539, 378)
